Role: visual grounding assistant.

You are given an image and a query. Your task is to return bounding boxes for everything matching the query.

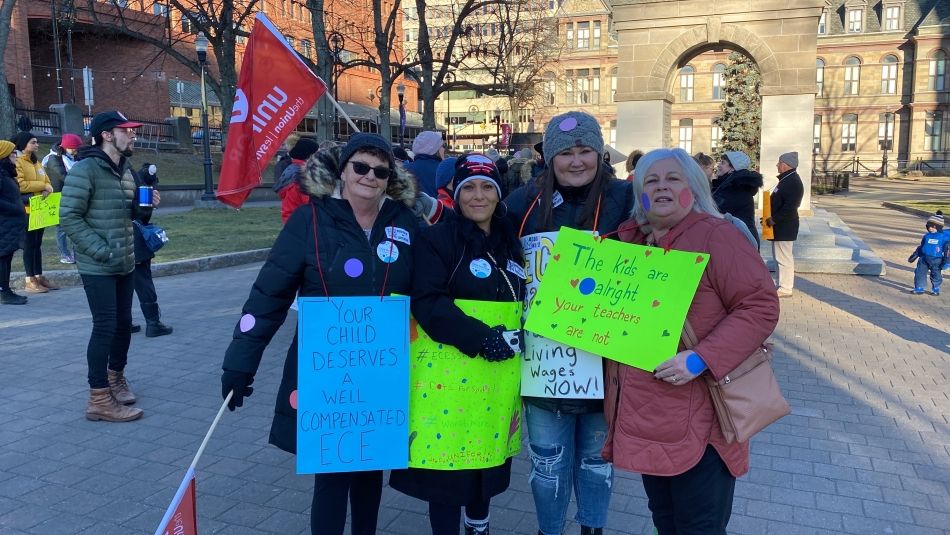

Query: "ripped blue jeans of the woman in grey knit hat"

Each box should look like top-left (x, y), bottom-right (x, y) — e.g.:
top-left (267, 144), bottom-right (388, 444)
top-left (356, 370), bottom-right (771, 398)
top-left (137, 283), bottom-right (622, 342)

top-left (525, 403), bottom-right (613, 535)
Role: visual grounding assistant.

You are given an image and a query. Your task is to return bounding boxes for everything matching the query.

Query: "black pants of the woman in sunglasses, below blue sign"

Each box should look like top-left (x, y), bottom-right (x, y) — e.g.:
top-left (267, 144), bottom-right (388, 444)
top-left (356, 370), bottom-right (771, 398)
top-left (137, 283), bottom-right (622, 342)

top-left (310, 470), bottom-right (383, 535)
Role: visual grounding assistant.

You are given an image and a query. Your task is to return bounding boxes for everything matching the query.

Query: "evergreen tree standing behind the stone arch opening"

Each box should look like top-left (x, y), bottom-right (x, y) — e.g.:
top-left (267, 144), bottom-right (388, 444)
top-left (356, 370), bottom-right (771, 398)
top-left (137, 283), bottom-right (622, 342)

top-left (715, 52), bottom-right (762, 169)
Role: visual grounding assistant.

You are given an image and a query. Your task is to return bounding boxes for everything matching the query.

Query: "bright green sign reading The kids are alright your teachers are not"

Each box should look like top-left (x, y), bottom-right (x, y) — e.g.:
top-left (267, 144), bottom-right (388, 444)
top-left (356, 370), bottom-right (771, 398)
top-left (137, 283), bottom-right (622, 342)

top-left (525, 227), bottom-right (709, 371)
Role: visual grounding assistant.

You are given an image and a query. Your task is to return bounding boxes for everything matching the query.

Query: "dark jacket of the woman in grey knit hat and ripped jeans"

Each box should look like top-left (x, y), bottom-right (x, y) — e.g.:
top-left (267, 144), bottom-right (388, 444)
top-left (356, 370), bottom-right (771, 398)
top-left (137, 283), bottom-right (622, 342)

top-left (505, 180), bottom-right (633, 414)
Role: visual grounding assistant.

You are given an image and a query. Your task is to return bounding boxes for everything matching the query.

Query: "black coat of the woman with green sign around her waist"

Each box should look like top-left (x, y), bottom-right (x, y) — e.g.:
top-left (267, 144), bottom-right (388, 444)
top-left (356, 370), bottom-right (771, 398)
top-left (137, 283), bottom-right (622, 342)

top-left (389, 217), bottom-right (524, 505)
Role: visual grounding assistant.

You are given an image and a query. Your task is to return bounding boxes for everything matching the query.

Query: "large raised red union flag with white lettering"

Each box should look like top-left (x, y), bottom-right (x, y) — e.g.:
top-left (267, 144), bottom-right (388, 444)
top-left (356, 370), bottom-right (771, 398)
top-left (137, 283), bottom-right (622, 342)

top-left (217, 13), bottom-right (327, 208)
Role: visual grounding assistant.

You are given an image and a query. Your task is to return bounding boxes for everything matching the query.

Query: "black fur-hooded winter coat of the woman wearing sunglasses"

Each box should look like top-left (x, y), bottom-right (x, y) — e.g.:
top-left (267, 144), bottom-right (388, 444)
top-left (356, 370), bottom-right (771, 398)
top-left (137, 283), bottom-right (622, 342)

top-left (222, 149), bottom-right (417, 453)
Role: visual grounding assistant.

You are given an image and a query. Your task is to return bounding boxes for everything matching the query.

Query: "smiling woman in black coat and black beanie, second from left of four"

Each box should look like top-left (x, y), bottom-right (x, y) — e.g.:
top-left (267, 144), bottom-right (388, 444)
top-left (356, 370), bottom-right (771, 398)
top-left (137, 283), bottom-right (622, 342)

top-left (389, 154), bottom-right (525, 535)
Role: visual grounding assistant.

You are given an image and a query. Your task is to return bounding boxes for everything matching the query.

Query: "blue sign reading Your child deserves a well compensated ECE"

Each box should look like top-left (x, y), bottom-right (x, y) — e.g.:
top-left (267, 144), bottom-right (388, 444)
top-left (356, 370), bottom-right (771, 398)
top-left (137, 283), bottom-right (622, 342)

top-left (296, 296), bottom-right (409, 474)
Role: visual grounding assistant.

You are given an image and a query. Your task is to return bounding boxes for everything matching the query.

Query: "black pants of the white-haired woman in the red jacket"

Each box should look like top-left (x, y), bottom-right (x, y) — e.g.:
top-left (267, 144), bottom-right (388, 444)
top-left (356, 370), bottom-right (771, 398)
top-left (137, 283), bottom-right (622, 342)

top-left (643, 446), bottom-right (736, 535)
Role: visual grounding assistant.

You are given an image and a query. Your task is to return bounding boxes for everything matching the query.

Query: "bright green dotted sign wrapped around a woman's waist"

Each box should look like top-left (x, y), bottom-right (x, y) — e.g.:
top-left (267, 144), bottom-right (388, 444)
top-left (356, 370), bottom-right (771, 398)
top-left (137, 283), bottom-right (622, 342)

top-left (409, 300), bottom-right (522, 470)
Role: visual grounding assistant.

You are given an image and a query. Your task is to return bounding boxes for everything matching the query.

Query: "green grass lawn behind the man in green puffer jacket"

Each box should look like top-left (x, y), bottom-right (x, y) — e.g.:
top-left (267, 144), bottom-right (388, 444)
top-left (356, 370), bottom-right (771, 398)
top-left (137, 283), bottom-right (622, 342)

top-left (13, 206), bottom-right (283, 272)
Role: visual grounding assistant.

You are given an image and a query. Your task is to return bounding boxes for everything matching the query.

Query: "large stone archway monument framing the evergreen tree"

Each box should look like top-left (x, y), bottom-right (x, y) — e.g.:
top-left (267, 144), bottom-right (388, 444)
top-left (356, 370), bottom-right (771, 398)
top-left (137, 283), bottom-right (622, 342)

top-left (613, 0), bottom-right (825, 211)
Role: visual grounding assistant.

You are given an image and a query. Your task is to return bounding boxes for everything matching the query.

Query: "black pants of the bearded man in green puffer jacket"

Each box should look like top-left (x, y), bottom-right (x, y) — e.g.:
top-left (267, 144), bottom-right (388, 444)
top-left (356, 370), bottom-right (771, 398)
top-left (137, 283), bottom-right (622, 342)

top-left (81, 273), bottom-right (133, 388)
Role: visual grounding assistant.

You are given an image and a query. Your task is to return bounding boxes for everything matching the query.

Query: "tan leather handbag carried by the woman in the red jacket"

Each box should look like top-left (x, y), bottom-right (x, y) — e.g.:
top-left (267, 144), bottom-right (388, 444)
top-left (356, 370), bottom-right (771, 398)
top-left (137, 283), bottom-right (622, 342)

top-left (682, 321), bottom-right (791, 442)
